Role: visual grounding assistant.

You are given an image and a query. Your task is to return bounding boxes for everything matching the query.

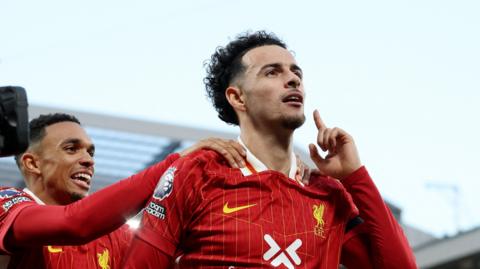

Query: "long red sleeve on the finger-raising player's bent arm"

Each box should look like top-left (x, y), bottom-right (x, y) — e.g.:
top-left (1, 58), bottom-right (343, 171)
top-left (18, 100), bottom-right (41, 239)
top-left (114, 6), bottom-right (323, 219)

top-left (342, 167), bottom-right (417, 269)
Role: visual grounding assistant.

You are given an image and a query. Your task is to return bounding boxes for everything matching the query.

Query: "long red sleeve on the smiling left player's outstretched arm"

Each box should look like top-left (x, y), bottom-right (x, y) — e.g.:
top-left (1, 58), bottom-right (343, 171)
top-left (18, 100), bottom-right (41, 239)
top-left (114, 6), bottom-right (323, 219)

top-left (4, 154), bottom-right (179, 248)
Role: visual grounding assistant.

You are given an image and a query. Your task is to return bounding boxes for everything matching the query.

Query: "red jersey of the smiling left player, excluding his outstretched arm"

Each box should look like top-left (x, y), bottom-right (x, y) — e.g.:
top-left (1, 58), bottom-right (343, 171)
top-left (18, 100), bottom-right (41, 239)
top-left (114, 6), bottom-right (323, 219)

top-left (0, 188), bottom-right (132, 269)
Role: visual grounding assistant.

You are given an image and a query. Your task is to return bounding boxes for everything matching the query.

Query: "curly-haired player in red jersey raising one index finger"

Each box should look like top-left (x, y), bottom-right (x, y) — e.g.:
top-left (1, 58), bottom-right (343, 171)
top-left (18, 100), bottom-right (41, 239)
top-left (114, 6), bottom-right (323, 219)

top-left (125, 31), bottom-right (415, 269)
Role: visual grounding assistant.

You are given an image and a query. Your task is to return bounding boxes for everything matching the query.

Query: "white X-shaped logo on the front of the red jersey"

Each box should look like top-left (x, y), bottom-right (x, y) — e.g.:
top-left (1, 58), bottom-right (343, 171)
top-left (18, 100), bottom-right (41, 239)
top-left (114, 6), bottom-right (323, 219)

top-left (263, 234), bottom-right (302, 269)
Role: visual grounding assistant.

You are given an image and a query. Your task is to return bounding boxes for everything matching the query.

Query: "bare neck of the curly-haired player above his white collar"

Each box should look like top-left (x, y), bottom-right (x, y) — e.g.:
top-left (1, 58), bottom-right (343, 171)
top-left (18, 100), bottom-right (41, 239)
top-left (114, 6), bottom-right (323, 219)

top-left (240, 120), bottom-right (293, 176)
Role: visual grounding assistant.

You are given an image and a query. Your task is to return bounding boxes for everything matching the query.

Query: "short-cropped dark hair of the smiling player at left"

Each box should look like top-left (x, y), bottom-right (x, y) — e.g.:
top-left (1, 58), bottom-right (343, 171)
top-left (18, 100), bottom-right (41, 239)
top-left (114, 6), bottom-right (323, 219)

top-left (15, 113), bottom-right (81, 167)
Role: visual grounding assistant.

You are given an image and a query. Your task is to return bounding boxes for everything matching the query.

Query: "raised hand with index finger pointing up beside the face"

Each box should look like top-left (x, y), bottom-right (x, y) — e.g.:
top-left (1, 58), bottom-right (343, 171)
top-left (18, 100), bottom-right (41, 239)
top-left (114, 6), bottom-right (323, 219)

top-left (309, 110), bottom-right (362, 180)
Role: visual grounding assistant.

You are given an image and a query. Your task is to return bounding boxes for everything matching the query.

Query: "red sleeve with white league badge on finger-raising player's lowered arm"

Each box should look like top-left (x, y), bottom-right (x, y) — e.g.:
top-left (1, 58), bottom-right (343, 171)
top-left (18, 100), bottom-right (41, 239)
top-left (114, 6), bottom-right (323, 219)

top-left (125, 152), bottom-right (204, 268)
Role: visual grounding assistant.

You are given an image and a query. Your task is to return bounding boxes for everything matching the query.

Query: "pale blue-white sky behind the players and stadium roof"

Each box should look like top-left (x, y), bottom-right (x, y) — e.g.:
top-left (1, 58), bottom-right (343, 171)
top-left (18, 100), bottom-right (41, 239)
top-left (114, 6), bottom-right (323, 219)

top-left (0, 0), bottom-right (480, 236)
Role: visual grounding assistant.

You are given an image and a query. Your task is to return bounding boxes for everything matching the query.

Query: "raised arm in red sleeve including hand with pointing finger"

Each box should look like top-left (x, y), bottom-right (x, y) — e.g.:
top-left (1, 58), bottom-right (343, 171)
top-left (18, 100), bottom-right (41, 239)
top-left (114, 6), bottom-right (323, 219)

top-left (310, 111), bottom-right (416, 269)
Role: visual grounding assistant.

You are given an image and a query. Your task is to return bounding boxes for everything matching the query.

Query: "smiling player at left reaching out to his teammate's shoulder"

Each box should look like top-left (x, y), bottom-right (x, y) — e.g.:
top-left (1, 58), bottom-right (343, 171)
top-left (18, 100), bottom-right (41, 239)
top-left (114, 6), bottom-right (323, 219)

top-left (0, 114), bottom-right (243, 269)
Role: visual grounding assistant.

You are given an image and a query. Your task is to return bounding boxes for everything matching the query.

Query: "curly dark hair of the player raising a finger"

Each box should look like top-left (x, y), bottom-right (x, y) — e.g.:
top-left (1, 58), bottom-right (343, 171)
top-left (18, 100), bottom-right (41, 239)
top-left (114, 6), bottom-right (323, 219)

top-left (203, 31), bottom-right (287, 125)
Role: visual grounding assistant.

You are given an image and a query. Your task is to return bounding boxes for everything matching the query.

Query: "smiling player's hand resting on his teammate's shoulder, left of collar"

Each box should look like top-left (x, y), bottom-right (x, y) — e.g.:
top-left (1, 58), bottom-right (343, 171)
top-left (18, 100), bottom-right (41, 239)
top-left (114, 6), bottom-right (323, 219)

top-left (179, 137), bottom-right (247, 168)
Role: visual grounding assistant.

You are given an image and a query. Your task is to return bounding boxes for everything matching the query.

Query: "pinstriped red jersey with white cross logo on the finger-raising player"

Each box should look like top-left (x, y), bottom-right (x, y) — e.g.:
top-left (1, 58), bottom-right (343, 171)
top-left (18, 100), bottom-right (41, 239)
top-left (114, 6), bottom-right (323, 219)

top-left (138, 150), bottom-right (357, 269)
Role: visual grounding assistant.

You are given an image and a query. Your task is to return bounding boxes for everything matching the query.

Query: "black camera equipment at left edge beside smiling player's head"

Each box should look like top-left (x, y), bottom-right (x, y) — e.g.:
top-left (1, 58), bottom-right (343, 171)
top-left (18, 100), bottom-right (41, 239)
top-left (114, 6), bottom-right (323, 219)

top-left (0, 86), bottom-right (28, 157)
